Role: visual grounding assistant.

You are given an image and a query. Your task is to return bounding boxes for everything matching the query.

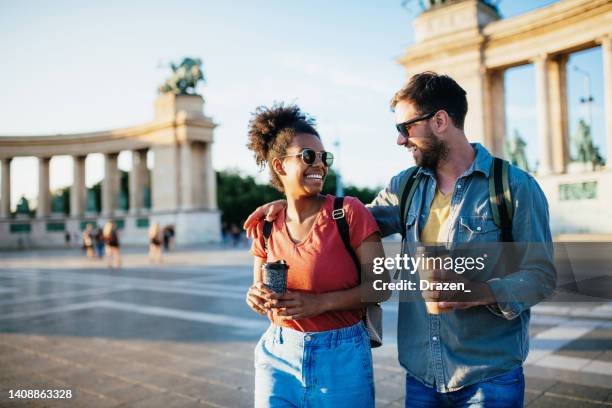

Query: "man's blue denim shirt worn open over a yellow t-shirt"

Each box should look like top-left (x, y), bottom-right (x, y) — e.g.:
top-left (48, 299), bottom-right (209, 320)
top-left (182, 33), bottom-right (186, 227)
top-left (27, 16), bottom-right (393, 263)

top-left (368, 143), bottom-right (556, 392)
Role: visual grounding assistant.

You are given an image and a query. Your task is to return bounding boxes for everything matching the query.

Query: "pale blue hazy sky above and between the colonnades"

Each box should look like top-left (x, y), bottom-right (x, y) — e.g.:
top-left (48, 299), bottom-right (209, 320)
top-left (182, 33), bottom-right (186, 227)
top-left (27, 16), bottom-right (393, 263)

top-left (0, 0), bottom-right (605, 207)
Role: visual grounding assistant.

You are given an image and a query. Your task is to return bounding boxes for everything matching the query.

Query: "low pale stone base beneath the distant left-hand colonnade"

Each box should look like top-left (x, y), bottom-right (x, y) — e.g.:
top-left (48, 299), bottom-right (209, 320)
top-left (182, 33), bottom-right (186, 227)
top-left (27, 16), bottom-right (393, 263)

top-left (0, 210), bottom-right (221, 249)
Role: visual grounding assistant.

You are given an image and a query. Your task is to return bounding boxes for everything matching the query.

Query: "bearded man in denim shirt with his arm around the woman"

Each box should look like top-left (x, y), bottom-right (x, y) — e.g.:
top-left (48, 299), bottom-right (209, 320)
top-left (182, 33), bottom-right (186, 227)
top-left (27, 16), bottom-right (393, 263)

top-left (245, 72), bottom-right (556, 407)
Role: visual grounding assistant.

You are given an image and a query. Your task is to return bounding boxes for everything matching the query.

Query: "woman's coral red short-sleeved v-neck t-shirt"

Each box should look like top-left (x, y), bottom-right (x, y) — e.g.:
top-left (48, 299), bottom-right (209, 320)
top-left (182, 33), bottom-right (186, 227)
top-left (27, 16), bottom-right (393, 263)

top-left (251, 195), bottom-right (379, 332)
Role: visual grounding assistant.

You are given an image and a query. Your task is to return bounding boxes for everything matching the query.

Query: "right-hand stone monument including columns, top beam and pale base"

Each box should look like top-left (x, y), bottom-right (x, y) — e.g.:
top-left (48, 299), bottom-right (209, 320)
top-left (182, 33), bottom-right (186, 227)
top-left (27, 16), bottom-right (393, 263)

top-left (398, 0), bottom-right (612, 234)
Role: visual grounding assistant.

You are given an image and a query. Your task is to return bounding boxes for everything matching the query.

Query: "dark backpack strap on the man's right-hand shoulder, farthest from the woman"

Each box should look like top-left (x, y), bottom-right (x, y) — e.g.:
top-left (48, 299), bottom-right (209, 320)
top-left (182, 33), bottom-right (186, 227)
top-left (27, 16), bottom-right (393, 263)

top-left (489, 157), bottom-right (514, 242)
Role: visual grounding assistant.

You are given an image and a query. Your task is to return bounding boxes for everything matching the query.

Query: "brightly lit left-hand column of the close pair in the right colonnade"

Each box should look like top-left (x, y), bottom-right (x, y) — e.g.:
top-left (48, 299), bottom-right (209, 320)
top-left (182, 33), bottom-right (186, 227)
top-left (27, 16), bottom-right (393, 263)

top-left (534, 54), bottom-right (552, 176)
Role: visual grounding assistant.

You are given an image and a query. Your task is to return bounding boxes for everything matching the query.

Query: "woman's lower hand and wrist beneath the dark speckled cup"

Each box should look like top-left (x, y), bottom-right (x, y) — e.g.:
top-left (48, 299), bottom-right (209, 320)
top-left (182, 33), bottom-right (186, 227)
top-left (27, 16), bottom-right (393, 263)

top-left (264, 290), bottom-right (327, 320)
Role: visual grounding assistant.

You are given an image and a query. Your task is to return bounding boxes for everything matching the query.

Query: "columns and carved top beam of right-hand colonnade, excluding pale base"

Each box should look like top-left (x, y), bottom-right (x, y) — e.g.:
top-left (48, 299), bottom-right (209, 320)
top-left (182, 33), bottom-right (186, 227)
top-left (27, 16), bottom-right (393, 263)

top-left (399, 0), bottom-right (612, 176)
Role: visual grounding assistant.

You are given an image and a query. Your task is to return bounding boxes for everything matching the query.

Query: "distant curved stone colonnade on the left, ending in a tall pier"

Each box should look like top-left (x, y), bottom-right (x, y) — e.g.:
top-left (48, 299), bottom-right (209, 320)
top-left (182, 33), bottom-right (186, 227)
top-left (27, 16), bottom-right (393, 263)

top-left (0, 94), bottom-right (219, 243)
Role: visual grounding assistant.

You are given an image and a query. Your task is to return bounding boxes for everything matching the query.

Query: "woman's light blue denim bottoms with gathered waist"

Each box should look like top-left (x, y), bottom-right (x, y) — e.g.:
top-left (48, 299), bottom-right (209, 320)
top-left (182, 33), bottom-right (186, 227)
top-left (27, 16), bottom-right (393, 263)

top-left (255, 322), bottom-right (374, 408)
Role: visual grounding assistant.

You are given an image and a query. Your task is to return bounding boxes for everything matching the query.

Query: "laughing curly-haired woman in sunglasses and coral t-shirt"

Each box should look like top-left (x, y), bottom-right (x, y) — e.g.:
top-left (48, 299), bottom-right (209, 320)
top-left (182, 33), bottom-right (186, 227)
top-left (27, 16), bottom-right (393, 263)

top-left (247, 104), bottom-right (388, 408)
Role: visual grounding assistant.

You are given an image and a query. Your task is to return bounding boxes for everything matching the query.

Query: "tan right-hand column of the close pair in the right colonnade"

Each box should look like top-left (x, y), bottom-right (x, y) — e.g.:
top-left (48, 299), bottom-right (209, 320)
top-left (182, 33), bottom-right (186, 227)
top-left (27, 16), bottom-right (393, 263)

top-left (548, 55), bottom-right (569, 173)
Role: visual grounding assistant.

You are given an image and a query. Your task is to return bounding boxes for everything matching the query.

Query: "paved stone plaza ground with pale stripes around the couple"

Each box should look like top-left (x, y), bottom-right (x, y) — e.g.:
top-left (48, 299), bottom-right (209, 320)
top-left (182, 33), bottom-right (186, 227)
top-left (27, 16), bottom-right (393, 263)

top-left (0, 248), bottom-right (612, 408)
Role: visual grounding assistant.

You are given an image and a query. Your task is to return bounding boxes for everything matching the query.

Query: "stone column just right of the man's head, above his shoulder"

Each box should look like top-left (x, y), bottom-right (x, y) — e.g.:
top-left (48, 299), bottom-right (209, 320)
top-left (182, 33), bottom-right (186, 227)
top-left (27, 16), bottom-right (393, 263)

top-left (484, 70), bottom-right (506, 157)
